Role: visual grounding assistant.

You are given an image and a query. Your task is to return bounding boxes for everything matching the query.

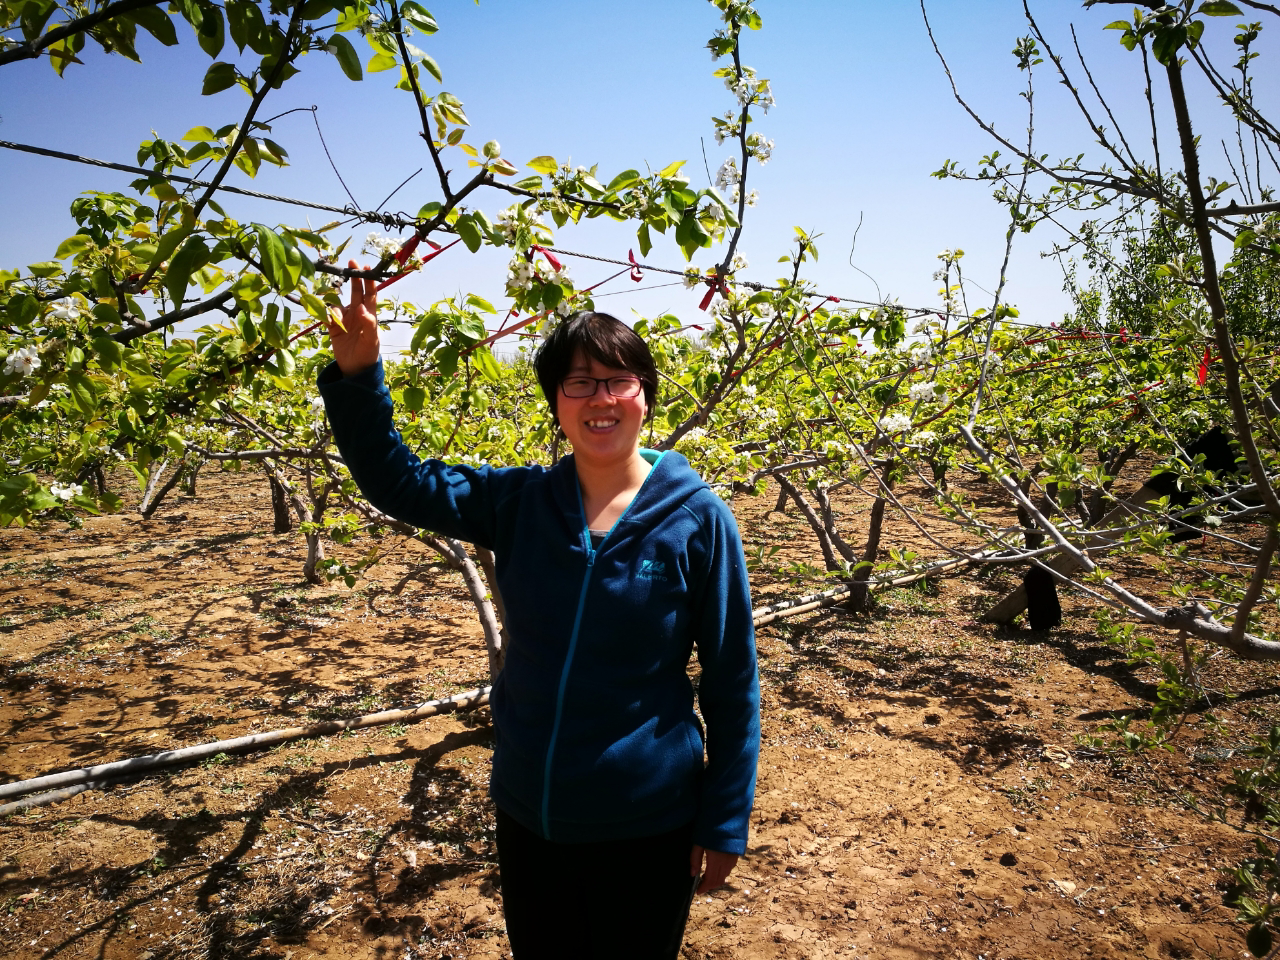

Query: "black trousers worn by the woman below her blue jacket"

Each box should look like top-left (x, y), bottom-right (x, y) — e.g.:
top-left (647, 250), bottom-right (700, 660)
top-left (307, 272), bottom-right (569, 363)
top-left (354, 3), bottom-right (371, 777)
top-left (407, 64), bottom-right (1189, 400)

top-left (498, 810), bottom-right (698, 960)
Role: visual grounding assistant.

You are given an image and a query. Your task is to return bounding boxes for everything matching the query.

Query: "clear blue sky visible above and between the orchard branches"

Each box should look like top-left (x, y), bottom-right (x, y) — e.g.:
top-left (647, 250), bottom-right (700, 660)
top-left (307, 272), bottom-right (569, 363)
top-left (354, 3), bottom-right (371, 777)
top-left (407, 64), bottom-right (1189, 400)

top-left (0, 0), bottom-right (1280, 355)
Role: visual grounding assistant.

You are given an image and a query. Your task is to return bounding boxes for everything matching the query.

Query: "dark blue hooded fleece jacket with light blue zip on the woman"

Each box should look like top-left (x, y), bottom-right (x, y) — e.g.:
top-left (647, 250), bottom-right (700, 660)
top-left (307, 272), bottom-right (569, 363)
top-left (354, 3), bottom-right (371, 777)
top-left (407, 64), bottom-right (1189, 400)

top-left (320, 364), bottom-right (760, 854)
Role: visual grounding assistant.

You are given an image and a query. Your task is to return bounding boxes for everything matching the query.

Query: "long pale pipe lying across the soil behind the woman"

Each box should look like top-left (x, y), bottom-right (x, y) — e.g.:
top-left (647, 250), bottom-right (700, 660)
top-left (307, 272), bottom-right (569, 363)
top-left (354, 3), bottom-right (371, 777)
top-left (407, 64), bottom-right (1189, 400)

top-left (0, 558), bottom-right (970, 817)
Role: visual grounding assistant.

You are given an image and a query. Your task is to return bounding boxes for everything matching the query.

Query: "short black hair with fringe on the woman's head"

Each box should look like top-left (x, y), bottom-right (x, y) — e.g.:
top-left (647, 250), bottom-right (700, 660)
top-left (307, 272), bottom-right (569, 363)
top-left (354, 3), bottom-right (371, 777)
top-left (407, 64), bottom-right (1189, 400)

top-left (534, 310), bottom-right (658, 422)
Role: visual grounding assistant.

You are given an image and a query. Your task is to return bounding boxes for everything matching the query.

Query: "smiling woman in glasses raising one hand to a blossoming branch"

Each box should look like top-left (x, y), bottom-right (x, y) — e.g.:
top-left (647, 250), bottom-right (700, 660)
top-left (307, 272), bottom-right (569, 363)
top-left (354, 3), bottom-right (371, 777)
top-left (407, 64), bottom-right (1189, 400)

top-left (320, 264), bottom-right (759, 960)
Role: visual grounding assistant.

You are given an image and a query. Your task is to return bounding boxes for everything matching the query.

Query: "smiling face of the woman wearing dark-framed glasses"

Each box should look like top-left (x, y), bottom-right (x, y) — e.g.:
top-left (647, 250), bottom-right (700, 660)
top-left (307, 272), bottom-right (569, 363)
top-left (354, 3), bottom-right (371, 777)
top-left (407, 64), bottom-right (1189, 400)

top-left (556, 352), bottom-right (648, 467)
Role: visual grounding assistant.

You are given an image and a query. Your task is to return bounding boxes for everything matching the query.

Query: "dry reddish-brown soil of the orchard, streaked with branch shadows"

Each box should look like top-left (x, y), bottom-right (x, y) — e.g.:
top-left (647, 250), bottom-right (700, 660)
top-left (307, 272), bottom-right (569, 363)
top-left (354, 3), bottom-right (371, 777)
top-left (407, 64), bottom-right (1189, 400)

top-left (0, 467), bottom-right (1280, 960)
